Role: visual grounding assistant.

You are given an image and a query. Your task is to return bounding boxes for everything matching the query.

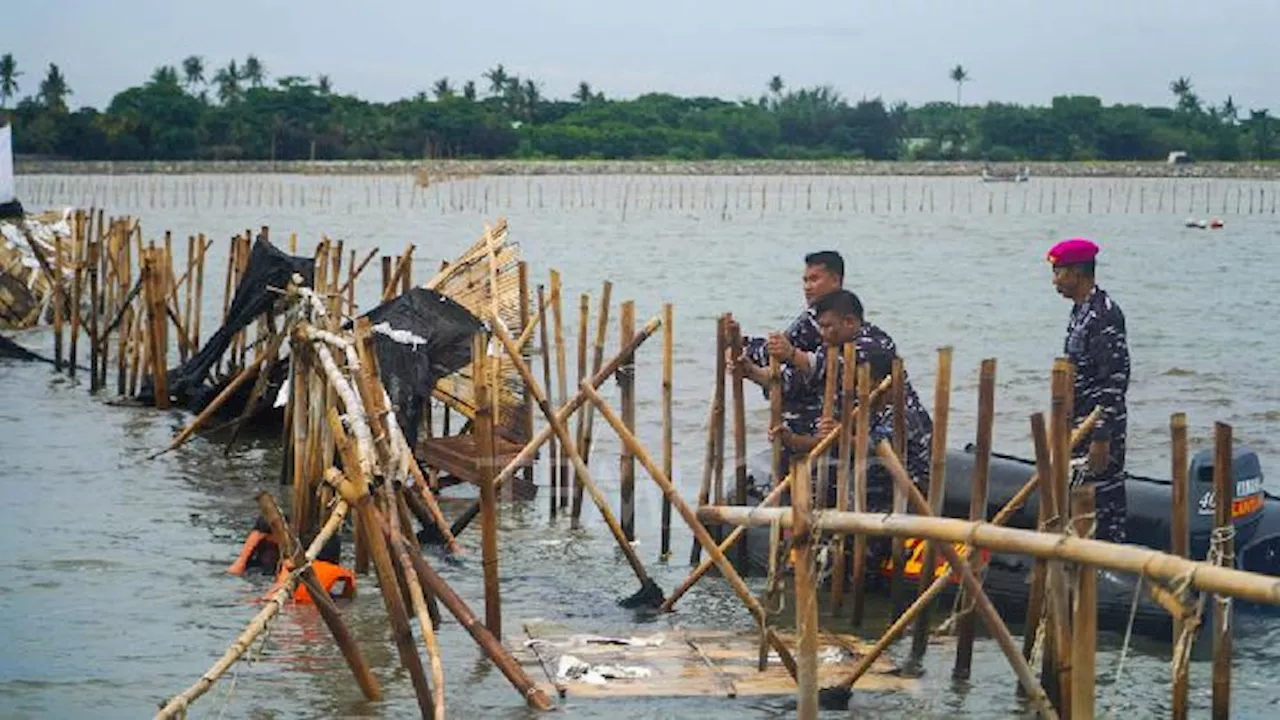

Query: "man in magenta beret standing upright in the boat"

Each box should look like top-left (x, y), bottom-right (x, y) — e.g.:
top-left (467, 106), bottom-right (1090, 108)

top-left (1048, 238), bottom-right (1129, 542)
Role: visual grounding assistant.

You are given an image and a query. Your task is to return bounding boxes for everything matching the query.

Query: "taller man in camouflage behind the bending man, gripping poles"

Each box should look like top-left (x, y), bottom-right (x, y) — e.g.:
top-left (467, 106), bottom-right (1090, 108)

top-left (730, 250), bottom-right (845, 433)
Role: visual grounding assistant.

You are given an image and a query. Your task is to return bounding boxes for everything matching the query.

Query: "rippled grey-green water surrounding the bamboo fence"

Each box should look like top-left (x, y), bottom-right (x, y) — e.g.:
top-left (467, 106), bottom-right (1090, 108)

top-left (0, 177), bottom-right (1280, 717)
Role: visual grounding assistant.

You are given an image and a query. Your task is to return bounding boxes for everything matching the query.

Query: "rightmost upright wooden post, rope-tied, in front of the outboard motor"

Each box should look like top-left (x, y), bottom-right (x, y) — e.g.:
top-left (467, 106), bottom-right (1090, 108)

top-left (1210, 420), bottom-right (1239, 720)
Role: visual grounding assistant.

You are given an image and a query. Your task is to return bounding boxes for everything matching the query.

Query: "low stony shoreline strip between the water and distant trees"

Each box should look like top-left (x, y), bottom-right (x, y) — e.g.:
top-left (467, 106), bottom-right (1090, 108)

top-left (14, 158), bottom-right (1280, 181)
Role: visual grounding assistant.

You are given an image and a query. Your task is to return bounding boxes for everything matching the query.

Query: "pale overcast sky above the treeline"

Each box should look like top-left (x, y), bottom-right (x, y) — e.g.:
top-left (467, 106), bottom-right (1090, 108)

top-left (10, 0), bottom-right (1280, 111)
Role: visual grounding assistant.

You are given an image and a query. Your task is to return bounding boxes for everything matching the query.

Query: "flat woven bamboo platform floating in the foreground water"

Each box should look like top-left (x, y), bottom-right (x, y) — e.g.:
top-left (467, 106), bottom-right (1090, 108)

top-left (507, 620), bottom-right (916, 698)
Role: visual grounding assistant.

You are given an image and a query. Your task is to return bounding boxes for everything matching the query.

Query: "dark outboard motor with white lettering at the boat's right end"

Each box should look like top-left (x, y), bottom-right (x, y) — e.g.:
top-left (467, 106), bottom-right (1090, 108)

top-left (1187, 447), bottom-right (1266, 565)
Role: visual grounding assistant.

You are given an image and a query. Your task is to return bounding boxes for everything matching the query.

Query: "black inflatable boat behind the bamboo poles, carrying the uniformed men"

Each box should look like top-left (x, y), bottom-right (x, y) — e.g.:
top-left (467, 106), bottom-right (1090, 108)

top-left (730, 446), bottom-right (1280, 637)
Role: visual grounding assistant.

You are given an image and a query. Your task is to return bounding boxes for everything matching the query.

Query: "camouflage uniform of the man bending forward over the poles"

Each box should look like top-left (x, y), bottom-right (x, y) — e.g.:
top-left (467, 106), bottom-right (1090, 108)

top-left (805, 323), bottom-right (933, 512)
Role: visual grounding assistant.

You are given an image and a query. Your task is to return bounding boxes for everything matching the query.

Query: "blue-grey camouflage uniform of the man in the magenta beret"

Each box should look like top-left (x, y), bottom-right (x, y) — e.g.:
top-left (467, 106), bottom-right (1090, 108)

top-left (1064, 287), bottom-right (1129, 542)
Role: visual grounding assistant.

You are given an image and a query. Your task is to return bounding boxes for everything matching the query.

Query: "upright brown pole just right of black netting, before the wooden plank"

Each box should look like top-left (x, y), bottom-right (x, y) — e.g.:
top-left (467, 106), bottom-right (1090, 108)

top-left (471, 330), bottom-right (504, 638)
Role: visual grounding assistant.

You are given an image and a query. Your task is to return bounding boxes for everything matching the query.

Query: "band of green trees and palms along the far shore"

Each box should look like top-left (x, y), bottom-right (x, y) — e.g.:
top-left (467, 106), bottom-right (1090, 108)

top-left (0, 55), bottom-right (1280, 161)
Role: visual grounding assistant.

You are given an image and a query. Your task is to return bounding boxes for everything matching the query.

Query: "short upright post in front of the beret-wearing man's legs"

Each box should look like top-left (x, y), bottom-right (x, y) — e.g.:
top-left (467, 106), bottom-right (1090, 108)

top-left (1071, 487), bottom-right (1100, 720)
